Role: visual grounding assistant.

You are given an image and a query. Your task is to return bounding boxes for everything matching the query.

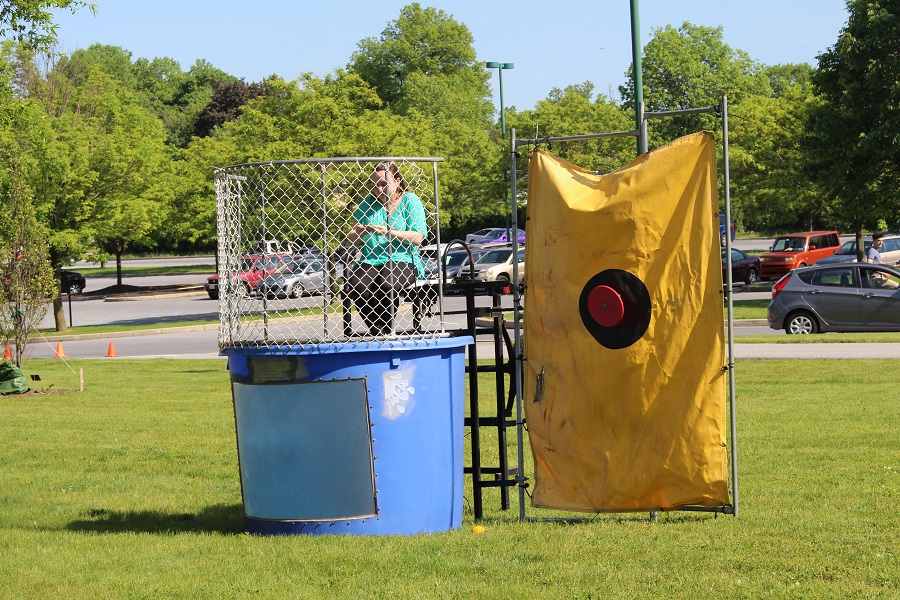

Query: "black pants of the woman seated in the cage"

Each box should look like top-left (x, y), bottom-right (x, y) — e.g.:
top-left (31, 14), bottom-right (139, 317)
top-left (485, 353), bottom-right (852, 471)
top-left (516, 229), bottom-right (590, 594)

top-left (347, 262), bottom-right (416, 335)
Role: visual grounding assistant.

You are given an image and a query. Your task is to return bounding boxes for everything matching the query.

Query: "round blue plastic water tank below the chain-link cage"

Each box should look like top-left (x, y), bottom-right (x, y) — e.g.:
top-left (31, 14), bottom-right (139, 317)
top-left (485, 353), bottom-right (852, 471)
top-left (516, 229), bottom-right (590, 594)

top-left (222, 337), bottom-right (472, 535)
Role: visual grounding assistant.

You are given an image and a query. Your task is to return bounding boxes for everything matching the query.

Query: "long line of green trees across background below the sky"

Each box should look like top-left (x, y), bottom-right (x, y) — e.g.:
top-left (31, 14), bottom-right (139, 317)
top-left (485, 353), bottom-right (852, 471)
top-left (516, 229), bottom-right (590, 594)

top-left (0, 0), bottom-right (900, 292)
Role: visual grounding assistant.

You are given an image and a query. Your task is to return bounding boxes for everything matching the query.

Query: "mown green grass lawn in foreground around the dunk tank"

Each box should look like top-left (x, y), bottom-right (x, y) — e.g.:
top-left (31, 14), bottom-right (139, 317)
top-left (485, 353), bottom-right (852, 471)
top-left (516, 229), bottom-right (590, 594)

top-left (0, 359), bottom-right (900, 599)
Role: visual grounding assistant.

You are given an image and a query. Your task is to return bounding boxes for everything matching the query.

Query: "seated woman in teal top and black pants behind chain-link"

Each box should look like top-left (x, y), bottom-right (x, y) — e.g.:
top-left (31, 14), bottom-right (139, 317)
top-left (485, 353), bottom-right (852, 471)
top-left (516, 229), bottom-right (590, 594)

top-left (347, 162), bottom-right (428, 335)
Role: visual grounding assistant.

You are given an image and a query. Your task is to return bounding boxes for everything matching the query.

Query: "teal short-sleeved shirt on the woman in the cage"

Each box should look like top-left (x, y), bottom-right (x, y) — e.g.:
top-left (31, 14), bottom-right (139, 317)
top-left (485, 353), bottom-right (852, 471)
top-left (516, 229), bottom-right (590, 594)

top-left (353, 192), bottom-right (428, 279)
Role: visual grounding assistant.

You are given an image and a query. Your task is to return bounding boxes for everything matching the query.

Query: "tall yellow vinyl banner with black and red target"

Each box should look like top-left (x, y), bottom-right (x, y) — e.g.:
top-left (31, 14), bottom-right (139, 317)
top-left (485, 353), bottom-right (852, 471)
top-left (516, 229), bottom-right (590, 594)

top-left (523, 132), bottom-right (729, 512)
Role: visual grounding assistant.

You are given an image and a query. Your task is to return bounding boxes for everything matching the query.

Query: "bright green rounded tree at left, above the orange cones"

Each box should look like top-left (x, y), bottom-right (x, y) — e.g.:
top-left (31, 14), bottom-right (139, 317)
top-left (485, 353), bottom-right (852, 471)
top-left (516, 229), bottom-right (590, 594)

top-left (14, 46), bottom-right (170, 316)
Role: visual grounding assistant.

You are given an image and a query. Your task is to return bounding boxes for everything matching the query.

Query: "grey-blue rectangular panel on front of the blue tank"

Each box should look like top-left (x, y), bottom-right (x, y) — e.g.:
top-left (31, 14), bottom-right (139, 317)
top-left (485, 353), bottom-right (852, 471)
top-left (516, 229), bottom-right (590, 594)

top-left (233, 379), bottom-right (377, 521)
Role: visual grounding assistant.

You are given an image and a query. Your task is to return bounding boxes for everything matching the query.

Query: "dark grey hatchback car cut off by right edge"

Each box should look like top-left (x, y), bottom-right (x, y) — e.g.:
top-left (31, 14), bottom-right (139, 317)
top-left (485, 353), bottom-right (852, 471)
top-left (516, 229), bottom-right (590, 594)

top-left (768, 263), bottom-right (900, 334)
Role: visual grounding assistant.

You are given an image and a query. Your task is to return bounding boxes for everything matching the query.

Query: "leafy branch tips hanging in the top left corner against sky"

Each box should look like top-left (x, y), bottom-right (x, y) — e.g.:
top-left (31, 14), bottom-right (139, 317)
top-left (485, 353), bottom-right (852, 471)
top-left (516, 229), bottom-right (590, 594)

top-left (0, 0), bottom-right (96, 49)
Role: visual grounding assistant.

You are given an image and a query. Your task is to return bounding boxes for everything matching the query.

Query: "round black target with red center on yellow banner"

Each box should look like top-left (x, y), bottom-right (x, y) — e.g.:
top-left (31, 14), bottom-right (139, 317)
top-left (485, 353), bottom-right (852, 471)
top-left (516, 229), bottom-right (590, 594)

top-left (578, 269), bottom-right (651, 350)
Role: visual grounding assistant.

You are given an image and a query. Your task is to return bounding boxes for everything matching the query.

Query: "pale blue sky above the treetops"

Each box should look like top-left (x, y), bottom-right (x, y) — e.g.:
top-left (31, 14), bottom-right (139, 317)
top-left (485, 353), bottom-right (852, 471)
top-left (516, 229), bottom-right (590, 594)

top-left (49, 0), bottom-right (848, 110)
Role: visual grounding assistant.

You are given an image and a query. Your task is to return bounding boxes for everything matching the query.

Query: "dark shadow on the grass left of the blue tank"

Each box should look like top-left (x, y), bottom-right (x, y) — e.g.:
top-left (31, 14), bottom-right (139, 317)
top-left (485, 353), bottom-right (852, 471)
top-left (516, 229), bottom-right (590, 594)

top-left (66, 504), bottom-right (244, 535)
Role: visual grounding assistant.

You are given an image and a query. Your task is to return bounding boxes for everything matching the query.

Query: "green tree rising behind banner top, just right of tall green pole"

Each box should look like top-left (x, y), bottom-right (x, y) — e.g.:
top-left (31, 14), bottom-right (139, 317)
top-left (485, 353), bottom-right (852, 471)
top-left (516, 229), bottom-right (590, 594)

top-left (619, 22), bottom-right (771, 148)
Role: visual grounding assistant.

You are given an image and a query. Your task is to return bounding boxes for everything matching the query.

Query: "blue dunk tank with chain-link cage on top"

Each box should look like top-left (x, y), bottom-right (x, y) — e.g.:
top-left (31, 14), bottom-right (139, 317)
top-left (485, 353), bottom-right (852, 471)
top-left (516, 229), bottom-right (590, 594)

top-left (210, 157), bottom-right (472, 535)
